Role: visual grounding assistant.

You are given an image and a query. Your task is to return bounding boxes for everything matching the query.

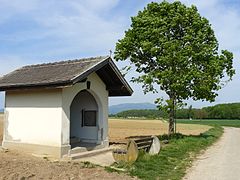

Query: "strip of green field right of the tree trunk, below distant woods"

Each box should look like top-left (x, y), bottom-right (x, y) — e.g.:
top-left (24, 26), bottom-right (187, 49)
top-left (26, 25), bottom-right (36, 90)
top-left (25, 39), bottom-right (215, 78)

top-left (177, 119), bottom-right (240, 127)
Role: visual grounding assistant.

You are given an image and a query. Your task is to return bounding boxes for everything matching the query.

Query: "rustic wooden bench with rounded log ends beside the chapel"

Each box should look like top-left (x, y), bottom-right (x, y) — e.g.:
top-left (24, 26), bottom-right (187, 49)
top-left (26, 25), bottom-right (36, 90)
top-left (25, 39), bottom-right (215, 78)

top-left (112, 136), bottom-right (160, 163)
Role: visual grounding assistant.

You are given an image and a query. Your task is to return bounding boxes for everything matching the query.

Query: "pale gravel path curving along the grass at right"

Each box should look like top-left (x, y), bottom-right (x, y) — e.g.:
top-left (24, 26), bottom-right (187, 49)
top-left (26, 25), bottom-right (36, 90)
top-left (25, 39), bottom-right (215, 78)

top-left (183, 127), bottom-right (240, 180)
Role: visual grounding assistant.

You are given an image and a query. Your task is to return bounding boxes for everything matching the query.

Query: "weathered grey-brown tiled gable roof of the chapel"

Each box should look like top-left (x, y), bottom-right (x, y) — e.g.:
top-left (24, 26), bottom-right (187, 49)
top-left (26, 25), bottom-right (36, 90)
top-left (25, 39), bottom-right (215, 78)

top-left (0, 56), bottom-right (132, 94)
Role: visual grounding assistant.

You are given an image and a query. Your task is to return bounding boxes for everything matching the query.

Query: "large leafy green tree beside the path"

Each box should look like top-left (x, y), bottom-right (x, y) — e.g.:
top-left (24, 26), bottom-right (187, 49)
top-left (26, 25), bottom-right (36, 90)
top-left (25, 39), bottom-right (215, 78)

top-left (114, 1), bottom-right (235, 134)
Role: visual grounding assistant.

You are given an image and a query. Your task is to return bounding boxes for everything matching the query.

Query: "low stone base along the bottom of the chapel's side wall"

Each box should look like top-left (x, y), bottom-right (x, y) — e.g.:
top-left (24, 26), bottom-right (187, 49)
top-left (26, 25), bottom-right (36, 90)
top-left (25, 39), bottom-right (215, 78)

top-left (2, 141), bottom-right (71, 158)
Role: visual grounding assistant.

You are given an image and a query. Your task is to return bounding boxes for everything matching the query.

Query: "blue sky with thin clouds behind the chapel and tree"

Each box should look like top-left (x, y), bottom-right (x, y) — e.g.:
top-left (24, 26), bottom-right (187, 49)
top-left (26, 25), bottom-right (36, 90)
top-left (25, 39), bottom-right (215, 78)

top-left (0, 0), bottom-right (240, 109)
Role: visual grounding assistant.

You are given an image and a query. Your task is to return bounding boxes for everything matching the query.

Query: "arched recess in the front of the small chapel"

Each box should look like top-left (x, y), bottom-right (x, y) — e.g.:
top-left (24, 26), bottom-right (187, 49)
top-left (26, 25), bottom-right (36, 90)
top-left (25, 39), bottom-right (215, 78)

top-left (70, 90), bottom-right (99, 148)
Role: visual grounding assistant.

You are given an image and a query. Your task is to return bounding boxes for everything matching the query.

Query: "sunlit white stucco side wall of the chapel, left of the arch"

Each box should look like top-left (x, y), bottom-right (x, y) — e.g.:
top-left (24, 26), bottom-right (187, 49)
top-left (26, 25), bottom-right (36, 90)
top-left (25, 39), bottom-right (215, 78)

top-left (4, 89), bottom-right (62, 146)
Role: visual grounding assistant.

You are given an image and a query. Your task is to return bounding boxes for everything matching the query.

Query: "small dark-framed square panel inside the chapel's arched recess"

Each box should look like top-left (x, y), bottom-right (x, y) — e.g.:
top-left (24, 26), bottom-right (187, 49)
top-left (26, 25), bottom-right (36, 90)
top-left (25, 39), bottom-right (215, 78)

top-left (82, 110), bottom-right (97, 126)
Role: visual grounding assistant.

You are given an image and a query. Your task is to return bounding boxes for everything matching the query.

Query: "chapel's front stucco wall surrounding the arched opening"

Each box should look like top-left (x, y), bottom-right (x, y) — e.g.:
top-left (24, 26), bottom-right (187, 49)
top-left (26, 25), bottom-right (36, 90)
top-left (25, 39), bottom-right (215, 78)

top-left (62, 73), bottom-right (108, 145)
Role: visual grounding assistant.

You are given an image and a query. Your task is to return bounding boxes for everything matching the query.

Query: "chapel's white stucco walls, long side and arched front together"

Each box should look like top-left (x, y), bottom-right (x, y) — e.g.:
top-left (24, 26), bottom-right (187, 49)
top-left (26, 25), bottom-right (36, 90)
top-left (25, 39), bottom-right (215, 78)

top-left (3, 73), bottom-right (108, 154)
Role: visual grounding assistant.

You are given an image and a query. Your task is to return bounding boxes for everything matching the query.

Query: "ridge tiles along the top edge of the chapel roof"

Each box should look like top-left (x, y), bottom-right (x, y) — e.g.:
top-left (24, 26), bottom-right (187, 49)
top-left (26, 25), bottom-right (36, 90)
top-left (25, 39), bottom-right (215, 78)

top-left (21, 56), bottom-right (109, 70)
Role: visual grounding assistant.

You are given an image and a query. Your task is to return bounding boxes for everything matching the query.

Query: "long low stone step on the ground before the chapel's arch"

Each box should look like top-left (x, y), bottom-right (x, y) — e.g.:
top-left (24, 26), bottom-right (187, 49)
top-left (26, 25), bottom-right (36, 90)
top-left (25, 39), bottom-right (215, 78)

top-left (68, 148), bottom-right (113, 160)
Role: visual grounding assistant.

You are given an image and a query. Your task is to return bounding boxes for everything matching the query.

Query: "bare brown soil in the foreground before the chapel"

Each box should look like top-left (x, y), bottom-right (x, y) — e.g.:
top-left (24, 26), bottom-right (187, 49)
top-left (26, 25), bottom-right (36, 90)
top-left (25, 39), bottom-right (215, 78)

top-left (0, 150), bottom-right (136, 180)
